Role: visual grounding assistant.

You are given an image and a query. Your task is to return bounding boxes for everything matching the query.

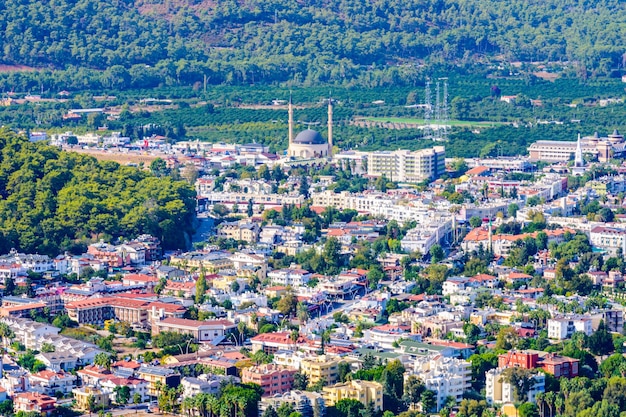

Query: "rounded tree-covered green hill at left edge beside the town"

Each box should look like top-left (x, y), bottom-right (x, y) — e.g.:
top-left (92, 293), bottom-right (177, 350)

top-left (0, 129), bottom-right (196, 256)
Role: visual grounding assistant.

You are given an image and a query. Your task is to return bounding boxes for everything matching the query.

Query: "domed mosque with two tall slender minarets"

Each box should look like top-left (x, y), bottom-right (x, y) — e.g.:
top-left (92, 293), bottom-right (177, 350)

top-left (287, 97), bottom-right (333, 159)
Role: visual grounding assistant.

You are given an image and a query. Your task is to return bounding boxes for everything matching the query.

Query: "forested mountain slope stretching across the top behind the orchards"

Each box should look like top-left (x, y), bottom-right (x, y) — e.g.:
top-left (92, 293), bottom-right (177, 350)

top-left (0, 0), bottom-right (626, 83)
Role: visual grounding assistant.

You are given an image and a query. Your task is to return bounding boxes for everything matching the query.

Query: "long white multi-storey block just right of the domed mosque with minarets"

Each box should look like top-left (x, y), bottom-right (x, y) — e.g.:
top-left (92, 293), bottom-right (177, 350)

top-left (367, 146), bottom-right (446, 182)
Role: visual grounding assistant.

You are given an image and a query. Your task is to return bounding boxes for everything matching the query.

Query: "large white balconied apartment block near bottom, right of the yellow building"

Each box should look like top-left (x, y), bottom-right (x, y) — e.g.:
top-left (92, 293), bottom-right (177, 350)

top-left (405, 355), bottom-right (472, 410)
